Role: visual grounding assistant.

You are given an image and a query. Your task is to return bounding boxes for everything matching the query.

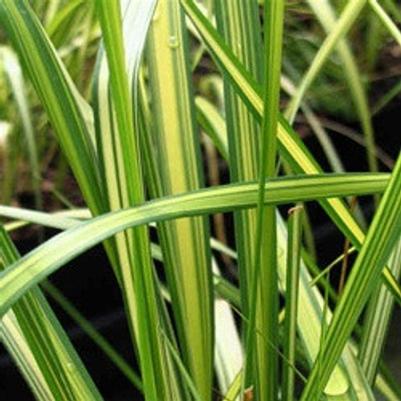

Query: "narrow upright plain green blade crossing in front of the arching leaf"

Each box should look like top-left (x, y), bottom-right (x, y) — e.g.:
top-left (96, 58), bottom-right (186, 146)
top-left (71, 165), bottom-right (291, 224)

top-left (245, 2), bottom-right (284, 401)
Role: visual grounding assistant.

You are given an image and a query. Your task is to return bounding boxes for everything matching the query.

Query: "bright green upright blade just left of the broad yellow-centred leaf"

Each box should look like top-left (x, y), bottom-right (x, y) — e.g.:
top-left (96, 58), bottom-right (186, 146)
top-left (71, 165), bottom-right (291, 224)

top-left (96, 0), bottom-right (174, 401)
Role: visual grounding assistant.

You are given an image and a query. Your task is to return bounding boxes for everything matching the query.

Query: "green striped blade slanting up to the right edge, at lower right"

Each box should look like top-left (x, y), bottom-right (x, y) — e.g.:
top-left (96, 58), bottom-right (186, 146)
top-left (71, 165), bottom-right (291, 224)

top-left (301, 149), bottom-right (401, 400)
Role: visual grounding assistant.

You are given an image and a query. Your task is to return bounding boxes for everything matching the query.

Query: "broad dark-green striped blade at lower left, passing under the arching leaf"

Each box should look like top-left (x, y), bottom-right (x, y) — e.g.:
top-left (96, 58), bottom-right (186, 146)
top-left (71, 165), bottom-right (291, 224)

top-left (0, 229), bottom-right (102, 401)
